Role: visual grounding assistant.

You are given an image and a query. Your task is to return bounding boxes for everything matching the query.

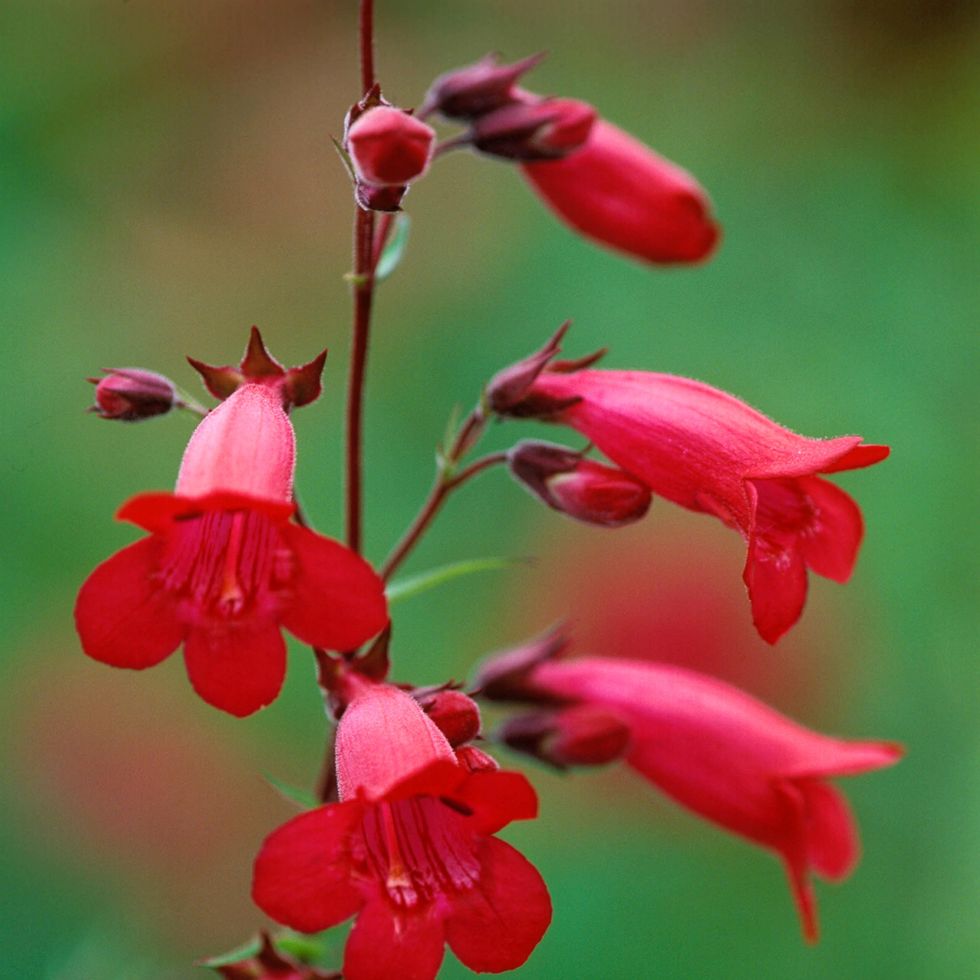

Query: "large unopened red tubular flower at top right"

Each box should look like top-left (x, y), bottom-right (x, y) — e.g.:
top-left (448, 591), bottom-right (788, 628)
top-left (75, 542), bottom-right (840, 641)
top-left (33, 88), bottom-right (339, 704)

top-left (521, 119), bottom-right (719, 264)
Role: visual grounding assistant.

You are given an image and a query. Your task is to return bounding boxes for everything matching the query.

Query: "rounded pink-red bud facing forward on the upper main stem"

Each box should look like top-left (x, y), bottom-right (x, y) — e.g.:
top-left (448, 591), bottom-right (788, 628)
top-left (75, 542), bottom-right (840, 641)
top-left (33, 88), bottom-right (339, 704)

top-left (347, 105), bottom-right (436, 187)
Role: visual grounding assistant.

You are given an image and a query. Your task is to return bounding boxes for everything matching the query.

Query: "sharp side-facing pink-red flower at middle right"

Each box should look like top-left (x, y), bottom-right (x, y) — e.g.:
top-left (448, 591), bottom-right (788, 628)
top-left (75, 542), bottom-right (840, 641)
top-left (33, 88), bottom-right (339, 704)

top-left (528, 370), bottom-right (888, 643)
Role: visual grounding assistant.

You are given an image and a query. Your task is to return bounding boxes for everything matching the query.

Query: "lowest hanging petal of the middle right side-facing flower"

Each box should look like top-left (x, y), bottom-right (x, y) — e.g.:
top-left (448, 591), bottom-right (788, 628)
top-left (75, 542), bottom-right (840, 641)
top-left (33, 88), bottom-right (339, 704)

top-left (742, 534), bottom-right (807, 643)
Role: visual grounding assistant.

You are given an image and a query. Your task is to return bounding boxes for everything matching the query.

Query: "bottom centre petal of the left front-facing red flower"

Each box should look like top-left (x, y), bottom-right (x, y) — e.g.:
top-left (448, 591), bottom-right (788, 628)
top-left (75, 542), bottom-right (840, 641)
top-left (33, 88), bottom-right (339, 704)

top-left (184, 620), bottom-right (286, 718)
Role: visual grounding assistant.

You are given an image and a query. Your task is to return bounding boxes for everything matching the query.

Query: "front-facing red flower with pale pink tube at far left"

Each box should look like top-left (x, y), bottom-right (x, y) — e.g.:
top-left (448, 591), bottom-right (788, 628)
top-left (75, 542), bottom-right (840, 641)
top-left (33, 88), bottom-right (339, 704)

top-left (75, 382), bottom-right (388, 716)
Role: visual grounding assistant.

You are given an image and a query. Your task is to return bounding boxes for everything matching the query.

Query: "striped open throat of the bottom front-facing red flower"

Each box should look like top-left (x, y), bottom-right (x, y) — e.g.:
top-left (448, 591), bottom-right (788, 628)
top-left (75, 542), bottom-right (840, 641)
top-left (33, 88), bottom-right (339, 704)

top-left (352, 797), bottom-right (480, 909)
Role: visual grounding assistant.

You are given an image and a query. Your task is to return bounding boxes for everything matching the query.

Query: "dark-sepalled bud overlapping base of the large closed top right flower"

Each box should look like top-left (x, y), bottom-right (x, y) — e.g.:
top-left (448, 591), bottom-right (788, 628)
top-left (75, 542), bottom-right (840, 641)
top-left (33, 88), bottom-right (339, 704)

top-left (470, 97), bottom-right (596, 160)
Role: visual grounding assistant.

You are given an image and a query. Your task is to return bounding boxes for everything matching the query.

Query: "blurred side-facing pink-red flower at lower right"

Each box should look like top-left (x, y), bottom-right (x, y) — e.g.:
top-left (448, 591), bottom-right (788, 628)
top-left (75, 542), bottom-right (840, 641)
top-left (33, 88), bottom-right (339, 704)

top-left (531, 658), bottom-right (902, 942)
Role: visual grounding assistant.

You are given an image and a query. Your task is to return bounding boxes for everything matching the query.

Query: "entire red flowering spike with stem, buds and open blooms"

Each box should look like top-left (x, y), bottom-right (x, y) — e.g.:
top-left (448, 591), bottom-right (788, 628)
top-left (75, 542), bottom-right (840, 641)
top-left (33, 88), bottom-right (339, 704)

top-left (75, 21), bottom-right (901, 980)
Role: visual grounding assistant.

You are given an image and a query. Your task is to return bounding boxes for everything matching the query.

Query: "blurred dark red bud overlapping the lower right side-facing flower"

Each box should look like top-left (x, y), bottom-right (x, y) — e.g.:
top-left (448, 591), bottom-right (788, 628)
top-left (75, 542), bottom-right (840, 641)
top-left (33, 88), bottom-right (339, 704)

top-left (495, 704), bottom-right (630, 769)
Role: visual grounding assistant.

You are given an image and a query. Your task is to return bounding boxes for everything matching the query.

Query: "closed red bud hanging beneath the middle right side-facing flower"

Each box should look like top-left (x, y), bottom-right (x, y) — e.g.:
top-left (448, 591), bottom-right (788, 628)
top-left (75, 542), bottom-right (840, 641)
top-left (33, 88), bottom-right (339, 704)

top-left (507, 440), bottom-right (651, 527)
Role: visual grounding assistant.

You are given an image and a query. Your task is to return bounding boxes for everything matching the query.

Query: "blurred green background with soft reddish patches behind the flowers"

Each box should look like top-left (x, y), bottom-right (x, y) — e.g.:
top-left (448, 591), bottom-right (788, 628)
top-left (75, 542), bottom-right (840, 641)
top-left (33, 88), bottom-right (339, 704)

top-left (0, 0), bottom-right (980, 980)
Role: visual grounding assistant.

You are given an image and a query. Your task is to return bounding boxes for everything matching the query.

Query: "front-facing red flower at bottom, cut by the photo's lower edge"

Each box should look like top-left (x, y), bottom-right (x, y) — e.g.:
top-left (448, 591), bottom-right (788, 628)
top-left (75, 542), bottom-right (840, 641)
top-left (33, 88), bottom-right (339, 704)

top-left (252, 681), bottom-right (551, 980)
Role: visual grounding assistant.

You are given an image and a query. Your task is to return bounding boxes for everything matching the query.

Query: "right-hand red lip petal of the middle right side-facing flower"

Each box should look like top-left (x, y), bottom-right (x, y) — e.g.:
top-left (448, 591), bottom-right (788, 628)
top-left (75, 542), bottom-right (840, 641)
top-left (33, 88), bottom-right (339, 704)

top-left (798, 476), bottom-right (864, 582)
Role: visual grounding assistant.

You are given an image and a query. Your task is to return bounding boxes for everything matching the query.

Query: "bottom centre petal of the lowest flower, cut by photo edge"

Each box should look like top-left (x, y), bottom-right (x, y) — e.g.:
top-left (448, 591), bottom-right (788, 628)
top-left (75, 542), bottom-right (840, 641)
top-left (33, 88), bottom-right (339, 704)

top-left (344, 896), bottom-right (445, 980)
